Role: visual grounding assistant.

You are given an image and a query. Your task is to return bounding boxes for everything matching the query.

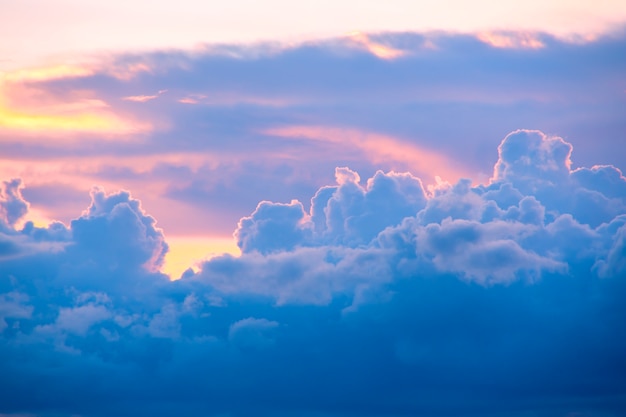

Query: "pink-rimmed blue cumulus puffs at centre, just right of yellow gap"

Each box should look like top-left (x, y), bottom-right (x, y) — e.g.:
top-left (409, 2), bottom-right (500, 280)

top-left (235, 167), bottom-right (426, 253)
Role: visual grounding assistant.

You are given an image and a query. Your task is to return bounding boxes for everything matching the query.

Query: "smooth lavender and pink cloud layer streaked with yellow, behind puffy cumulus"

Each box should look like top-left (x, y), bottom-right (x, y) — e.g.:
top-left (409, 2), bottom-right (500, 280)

top-left (0, 31), bottom-right (626, 237)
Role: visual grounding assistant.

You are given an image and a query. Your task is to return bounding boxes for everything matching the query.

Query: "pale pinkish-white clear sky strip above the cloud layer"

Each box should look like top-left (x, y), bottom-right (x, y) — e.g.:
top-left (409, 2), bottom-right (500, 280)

top-left (0, 0), bottom-right (626, 69)
